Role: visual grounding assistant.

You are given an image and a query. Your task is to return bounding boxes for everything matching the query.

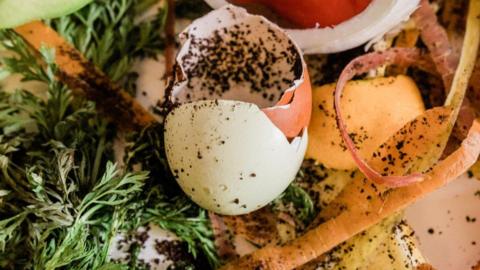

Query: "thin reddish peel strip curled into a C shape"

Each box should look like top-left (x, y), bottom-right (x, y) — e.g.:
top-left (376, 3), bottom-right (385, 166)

top-left (334, 48), bottom-right (433, 187)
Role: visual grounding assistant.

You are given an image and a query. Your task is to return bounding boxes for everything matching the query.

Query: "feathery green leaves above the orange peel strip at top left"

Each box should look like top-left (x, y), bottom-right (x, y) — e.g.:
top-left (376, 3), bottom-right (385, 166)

top-left (50, 0), bottom-right (167, 94)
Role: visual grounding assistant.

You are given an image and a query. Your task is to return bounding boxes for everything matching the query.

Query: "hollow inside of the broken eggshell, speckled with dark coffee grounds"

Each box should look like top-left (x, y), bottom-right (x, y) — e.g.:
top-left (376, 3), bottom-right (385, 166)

top-left (172, 6), bottom-right (311, 139)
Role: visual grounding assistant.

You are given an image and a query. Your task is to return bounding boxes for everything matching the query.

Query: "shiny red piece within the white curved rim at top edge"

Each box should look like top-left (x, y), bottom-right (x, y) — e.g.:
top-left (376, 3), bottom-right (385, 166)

top-left (231, 0), bottom-right (372, 28)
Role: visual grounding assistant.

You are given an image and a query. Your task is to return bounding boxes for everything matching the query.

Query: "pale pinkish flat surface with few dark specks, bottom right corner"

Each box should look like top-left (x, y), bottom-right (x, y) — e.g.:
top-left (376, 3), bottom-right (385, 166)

top-left (406, 175), bottom-right (480, 270)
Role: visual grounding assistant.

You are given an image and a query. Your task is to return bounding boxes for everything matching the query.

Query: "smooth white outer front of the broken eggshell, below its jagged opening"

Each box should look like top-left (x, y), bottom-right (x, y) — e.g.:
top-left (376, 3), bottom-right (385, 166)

top-left (165, 100), bottom-right (308, 215)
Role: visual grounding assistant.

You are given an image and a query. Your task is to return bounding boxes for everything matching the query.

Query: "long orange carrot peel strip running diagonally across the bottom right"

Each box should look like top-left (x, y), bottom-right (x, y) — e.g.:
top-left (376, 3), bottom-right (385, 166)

top-left (223, 0), bottom-right (480, 269)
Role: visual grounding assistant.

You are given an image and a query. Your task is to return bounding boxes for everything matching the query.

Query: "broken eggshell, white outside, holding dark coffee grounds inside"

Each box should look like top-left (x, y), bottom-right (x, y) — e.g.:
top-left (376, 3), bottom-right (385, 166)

top-left (165, 6), bottom-right (312, 215)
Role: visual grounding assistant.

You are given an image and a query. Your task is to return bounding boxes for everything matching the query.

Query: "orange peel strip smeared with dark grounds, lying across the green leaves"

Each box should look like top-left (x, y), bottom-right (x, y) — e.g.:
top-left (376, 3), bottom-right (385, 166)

top-left (14, 21), bottom-right (156, 130)
